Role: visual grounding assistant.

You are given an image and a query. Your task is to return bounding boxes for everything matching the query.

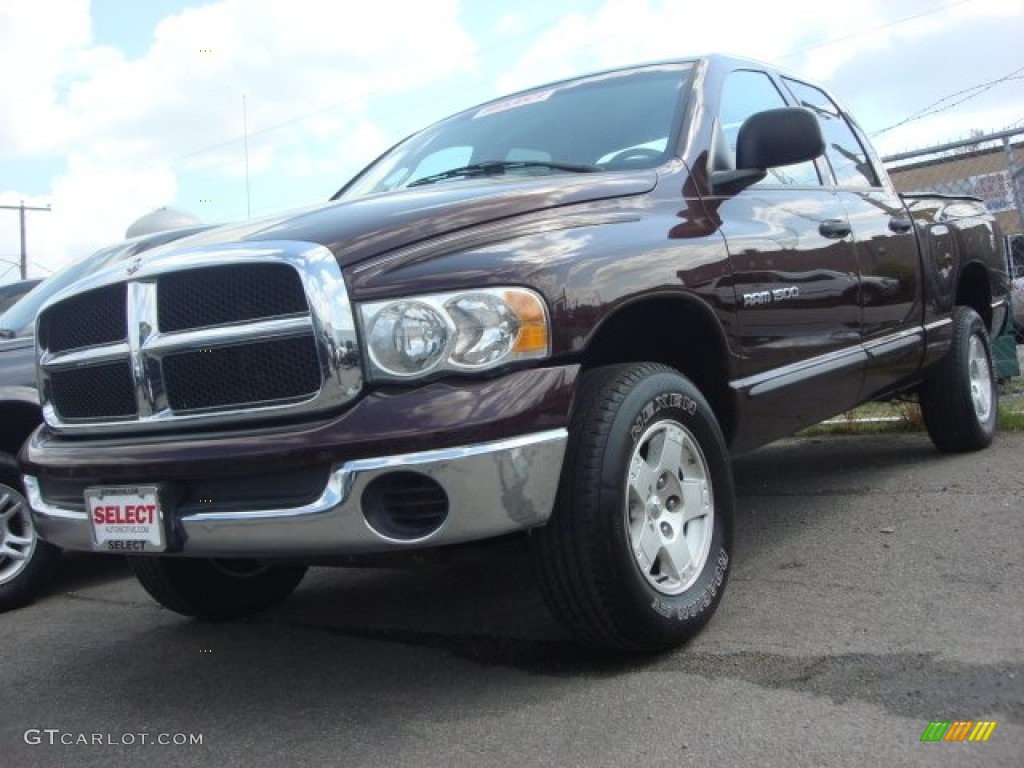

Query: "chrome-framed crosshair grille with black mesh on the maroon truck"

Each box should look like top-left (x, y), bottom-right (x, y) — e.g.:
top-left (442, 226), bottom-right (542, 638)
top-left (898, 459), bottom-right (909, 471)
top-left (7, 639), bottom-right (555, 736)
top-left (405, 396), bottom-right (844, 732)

top-left (38, 243), bottom-right (362, 432)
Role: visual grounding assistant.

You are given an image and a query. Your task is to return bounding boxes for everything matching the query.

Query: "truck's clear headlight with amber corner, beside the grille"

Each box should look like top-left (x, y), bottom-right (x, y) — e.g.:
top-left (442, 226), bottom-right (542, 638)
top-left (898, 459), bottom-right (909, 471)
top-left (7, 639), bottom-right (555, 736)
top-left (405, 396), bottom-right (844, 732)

top-left (359, 288), bottom-right (550, 380)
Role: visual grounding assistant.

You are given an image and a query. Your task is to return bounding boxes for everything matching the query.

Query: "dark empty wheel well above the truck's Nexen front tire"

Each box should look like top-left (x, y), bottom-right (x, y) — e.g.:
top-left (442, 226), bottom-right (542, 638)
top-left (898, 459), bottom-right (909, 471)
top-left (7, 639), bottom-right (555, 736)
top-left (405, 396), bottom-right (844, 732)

top-left (582, 298), bottom-right (734, 443)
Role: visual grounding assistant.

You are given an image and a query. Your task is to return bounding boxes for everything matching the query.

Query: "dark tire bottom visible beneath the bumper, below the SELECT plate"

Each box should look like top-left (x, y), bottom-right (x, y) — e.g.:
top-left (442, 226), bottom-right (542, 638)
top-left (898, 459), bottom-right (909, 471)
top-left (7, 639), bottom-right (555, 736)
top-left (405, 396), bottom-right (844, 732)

top-left (128, 556), bottom-right (306, 621)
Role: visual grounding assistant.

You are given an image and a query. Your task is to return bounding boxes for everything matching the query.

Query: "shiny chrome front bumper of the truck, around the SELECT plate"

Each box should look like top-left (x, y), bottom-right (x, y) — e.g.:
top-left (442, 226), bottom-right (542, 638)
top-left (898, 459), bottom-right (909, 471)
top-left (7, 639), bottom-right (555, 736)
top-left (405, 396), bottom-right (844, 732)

top-left (25, 429), bottom-right (567, 558)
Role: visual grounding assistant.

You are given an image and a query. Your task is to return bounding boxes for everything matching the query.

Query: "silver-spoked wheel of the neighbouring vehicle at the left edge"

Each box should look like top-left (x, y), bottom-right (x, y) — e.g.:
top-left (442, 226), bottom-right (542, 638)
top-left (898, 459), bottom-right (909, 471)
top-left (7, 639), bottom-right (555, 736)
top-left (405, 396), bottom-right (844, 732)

top-left (0, 455), bottom-right (60, 611)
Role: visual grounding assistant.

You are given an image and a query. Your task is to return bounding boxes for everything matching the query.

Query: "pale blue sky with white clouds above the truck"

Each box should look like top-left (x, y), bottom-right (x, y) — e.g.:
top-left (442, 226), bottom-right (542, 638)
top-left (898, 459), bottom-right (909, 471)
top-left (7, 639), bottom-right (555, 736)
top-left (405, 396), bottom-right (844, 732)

top-left (0, 0), bottom-right (1024, 283)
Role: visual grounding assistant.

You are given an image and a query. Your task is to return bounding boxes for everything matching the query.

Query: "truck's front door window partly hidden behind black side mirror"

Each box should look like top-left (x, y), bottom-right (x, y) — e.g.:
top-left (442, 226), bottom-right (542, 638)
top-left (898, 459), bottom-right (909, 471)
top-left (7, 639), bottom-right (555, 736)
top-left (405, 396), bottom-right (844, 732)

top-left (712, 70), bottom-right (821, 185)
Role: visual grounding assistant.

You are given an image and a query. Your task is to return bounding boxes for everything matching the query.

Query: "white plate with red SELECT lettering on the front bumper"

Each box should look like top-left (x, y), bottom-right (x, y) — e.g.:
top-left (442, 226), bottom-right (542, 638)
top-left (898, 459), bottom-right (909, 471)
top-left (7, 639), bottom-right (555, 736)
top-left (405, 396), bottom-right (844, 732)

top-left (85, 485), bottom-right (167, 554)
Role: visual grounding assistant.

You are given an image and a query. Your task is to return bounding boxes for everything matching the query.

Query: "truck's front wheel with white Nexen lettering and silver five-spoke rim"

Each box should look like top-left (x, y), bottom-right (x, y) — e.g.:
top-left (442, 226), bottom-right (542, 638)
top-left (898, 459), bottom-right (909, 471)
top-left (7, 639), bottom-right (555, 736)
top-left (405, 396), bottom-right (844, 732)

top-left (532, 364), bottom-right (734, 651)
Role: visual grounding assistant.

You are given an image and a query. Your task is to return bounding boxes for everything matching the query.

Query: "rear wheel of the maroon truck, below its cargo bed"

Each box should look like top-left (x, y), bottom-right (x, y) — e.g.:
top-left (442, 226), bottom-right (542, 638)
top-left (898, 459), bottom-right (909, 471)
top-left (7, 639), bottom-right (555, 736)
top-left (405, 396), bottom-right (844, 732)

top-left (920, 306), bottom-right (999, 454)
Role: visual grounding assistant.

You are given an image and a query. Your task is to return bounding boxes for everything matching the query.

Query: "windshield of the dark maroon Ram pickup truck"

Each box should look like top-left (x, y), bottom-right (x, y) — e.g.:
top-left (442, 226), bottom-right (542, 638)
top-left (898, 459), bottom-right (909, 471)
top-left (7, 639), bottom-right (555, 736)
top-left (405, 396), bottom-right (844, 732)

top-left (335, 62), bottom-right (693, 199)
